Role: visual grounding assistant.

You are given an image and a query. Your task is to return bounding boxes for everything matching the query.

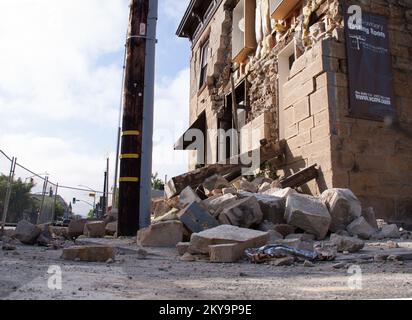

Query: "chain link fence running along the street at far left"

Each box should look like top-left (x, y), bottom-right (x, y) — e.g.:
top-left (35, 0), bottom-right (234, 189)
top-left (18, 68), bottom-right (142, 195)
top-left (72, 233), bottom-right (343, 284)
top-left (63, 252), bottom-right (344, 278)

top-left (0, 150), bottom-right (109, 226)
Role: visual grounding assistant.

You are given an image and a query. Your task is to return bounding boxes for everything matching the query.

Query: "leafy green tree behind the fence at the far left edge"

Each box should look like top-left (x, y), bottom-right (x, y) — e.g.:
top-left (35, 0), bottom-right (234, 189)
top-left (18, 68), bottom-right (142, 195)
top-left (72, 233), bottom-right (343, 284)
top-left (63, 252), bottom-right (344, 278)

top-left (0, 175), bottom-right (34, 222)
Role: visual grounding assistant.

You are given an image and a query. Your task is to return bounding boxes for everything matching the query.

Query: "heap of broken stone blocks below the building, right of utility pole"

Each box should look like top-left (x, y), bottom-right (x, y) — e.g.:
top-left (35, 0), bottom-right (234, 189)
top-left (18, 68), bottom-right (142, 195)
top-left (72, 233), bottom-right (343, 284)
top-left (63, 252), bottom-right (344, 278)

top-left (143, 175), bottom-right (412, 265)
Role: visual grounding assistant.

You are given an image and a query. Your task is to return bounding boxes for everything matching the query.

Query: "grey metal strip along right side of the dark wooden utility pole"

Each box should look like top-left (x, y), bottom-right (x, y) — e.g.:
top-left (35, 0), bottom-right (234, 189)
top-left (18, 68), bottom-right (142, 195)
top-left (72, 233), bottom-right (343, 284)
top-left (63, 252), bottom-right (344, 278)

top-left (140, 0), bottom-right (158, 228)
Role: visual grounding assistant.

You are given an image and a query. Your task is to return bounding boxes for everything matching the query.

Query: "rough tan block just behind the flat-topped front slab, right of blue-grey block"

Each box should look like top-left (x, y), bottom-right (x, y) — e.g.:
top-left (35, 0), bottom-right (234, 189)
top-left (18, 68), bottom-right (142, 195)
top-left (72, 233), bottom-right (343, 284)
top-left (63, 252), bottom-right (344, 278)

top-left (219, 197), bottom-right (263, 228)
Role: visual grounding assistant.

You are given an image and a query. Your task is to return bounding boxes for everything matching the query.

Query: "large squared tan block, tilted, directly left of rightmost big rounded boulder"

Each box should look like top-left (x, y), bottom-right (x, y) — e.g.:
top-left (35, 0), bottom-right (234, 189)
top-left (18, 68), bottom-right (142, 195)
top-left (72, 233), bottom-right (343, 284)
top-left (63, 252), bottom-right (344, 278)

top-left (285, 194), bottom-right (332, 240)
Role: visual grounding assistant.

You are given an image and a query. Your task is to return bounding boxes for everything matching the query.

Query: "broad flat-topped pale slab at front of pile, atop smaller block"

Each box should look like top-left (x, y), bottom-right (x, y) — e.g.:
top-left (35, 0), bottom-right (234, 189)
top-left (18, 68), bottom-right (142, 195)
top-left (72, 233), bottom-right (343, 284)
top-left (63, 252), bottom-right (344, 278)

top-left (189, 225), bottom-right (269, 254)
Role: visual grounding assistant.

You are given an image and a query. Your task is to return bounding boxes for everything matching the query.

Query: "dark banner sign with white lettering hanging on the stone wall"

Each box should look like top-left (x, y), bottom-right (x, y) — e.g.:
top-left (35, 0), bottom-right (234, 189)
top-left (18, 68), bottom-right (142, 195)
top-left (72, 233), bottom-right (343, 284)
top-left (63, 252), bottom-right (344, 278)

top-left (345, 7), bottom-right (396, 120)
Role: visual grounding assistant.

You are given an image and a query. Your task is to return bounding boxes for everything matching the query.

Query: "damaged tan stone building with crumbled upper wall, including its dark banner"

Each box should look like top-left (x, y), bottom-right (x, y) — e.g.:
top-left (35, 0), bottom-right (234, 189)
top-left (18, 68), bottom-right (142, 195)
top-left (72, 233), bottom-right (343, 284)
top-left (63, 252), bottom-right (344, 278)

top-left (175, 0), bottom-right (412, 226)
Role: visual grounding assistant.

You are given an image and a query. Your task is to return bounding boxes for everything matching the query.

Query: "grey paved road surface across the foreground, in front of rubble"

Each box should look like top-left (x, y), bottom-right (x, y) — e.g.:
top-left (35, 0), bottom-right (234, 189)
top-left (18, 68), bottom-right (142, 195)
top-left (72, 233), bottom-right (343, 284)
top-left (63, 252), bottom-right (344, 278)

top-left (0, 243), bottom-right (412, 300)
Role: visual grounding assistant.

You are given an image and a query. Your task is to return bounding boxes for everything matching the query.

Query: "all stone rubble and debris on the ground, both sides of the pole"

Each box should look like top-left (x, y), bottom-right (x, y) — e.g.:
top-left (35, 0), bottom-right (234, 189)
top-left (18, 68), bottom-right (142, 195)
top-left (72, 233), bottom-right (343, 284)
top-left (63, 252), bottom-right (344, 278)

top-left (1, 170), bottom-right (412, 268)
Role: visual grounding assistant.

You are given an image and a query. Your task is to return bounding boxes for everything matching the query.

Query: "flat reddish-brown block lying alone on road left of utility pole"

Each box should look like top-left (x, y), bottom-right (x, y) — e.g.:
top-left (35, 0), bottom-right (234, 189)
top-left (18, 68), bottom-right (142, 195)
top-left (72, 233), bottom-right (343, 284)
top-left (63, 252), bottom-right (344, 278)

top-left (62, 246), bottom-right (116, 262)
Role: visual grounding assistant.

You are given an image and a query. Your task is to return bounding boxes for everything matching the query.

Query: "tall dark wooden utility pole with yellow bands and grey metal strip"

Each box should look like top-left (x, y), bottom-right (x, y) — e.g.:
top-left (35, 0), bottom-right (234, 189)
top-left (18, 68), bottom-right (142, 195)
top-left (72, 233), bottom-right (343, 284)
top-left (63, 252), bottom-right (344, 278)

top-left (118, 0), bottom-right (157, 237)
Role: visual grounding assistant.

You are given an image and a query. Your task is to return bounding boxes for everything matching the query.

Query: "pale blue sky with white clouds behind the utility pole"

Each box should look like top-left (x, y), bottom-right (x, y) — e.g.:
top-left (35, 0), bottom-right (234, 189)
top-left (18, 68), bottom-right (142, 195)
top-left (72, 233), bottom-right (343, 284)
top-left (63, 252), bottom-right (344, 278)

top-left (0, 0), bottom-right (190, 214)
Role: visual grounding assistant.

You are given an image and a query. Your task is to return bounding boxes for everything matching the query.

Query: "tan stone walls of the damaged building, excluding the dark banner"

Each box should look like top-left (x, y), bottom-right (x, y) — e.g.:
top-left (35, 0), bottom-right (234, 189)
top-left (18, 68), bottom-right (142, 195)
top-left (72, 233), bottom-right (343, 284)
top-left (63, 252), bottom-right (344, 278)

top-left (176, 0), bottom-right (412, 224)
